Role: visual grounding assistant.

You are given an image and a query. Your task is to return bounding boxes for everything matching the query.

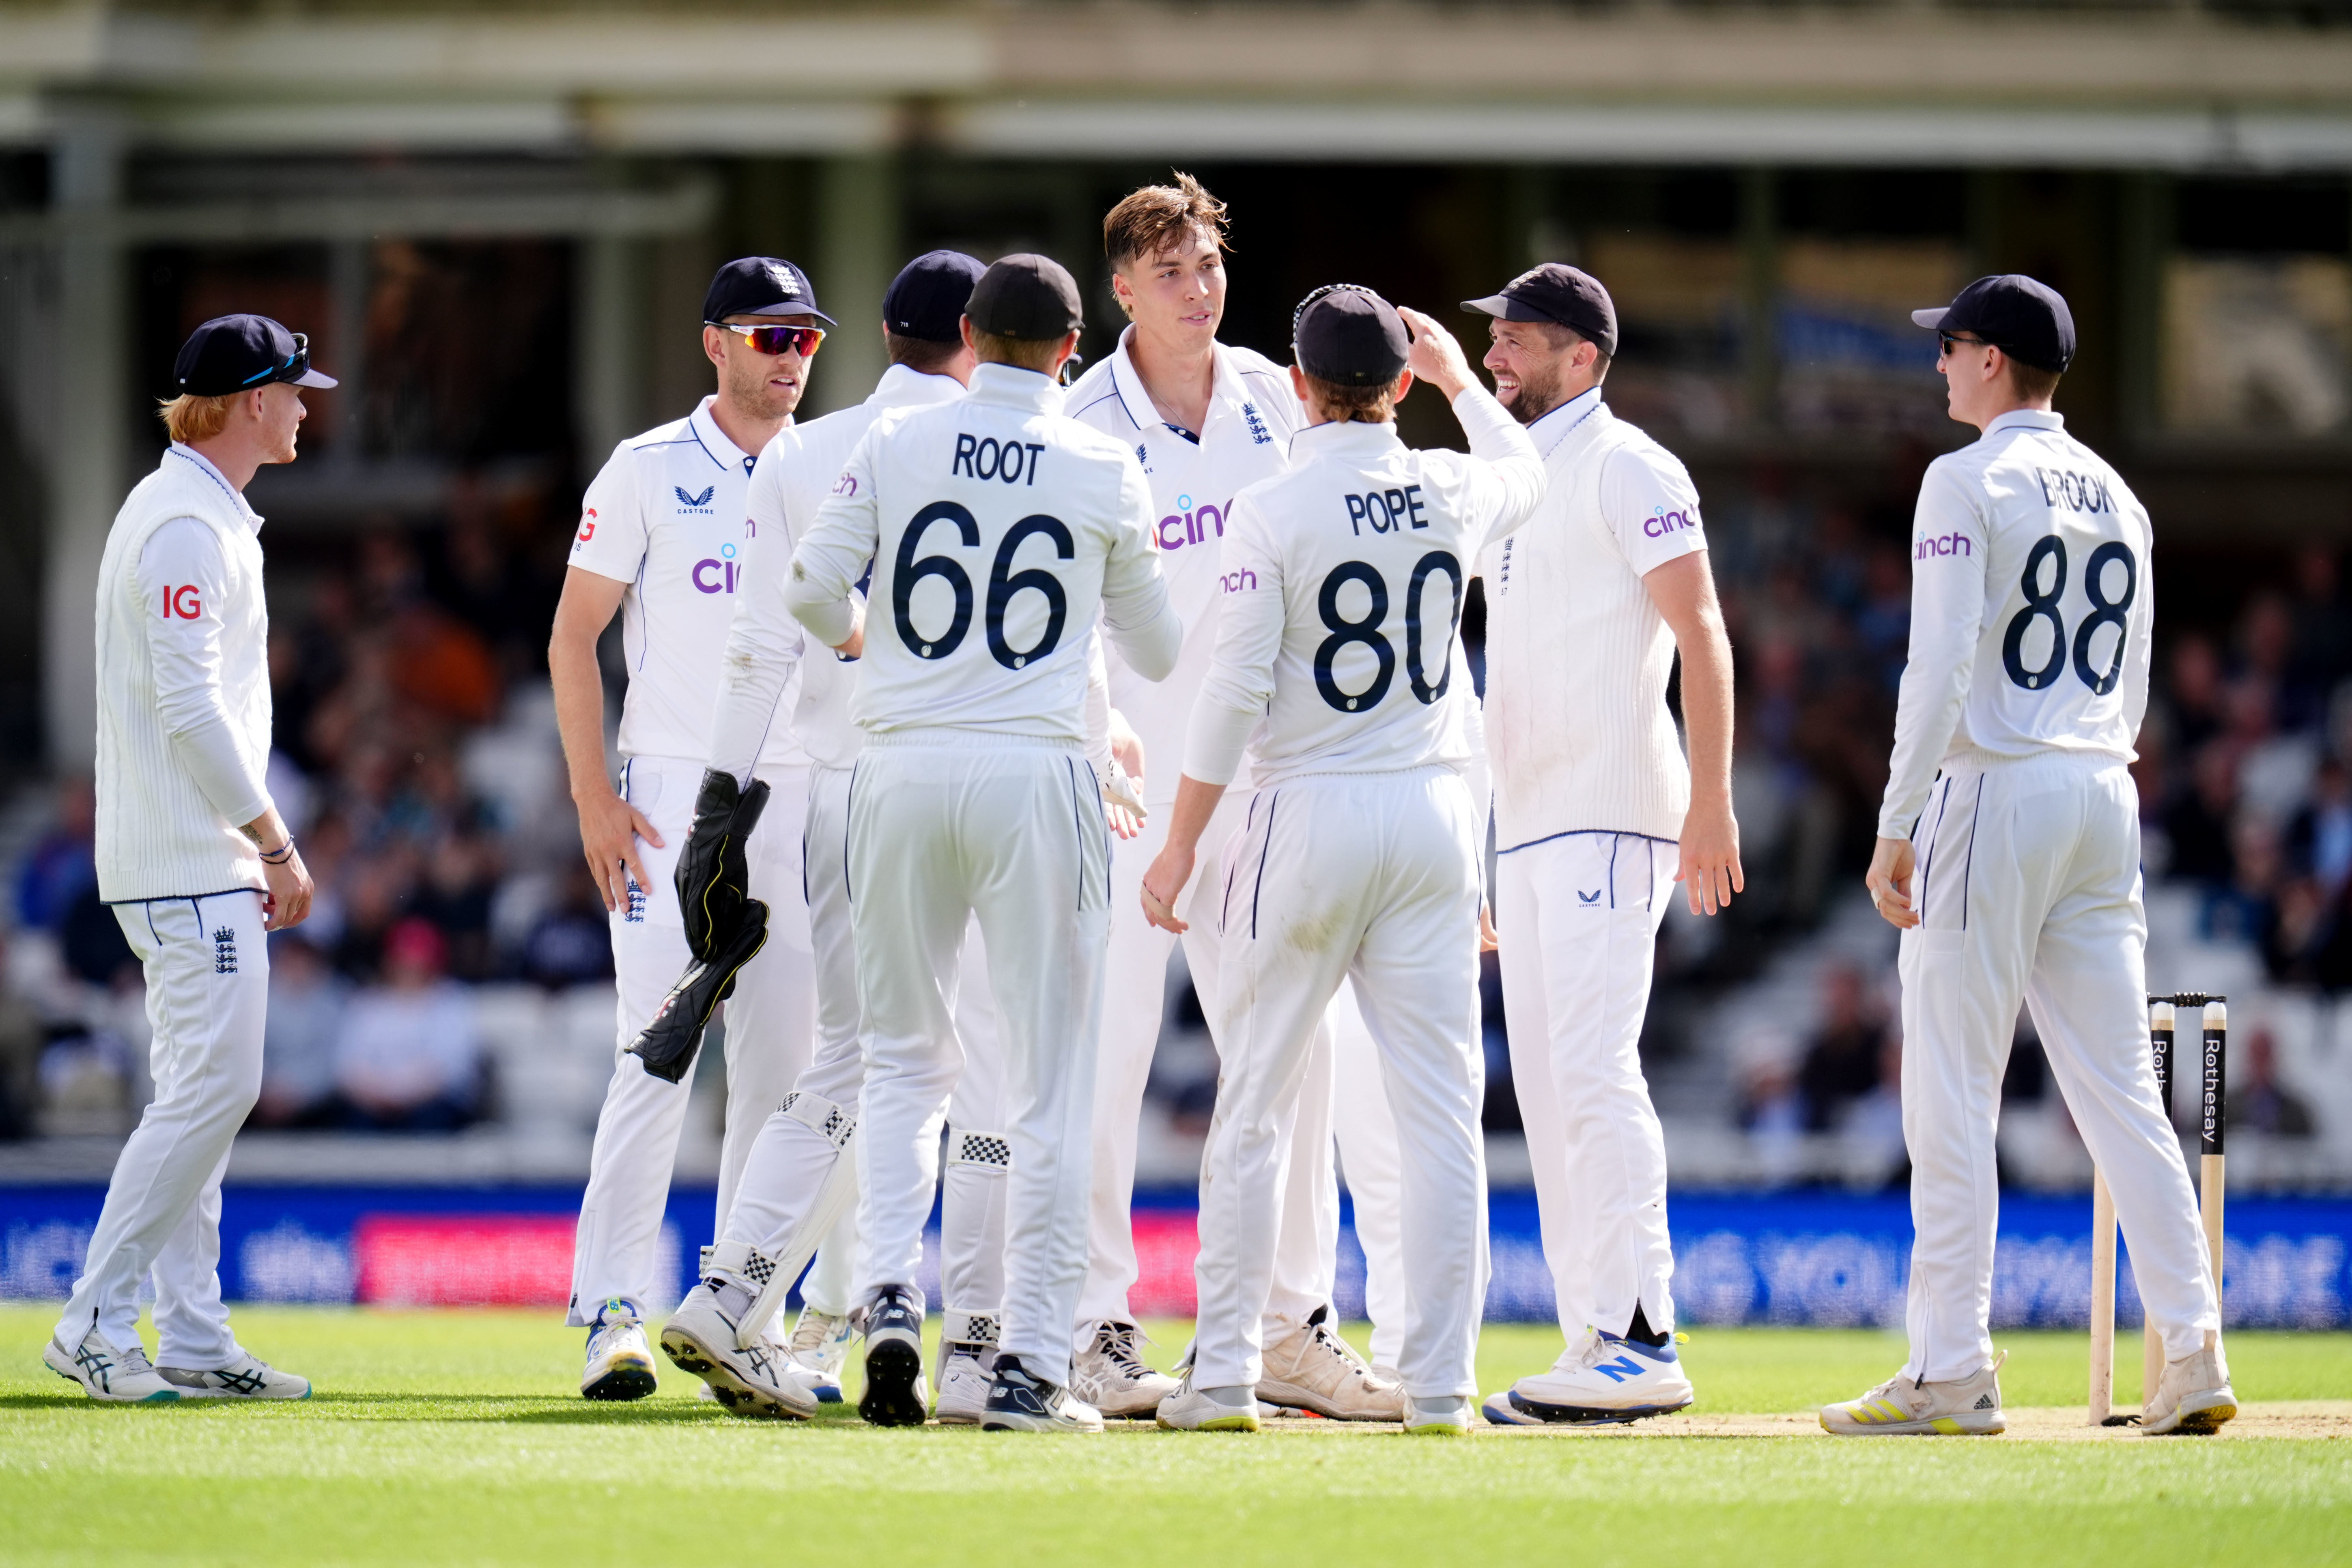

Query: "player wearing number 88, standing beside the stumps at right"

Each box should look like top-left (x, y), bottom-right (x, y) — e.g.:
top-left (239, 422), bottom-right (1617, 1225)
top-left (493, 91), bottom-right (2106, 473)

top-left (1820, 275), bottom-right (2237, 1437)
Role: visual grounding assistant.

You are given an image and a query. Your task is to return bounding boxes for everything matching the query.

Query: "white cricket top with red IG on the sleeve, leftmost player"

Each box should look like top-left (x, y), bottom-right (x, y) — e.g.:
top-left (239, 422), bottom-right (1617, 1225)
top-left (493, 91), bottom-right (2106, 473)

top-left (97, 444), bottom-right (271, 903)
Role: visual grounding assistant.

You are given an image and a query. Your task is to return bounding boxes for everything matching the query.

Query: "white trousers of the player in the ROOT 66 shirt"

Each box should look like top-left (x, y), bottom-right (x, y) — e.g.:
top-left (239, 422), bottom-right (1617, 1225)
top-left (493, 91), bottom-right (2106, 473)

top-left (849, 731), bottom-right (1110, 1382)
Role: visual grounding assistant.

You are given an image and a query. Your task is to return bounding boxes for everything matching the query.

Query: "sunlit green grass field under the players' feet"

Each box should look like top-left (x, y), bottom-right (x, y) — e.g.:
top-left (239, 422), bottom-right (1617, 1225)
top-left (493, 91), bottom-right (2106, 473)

top-left (0, 1307), bottom-right (2352, 1568)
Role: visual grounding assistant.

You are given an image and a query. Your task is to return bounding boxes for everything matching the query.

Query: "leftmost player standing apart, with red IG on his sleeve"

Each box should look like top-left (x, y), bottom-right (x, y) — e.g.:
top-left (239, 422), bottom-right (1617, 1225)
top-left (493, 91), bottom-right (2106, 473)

top-left (40, 315), bottom-right (334, 1403)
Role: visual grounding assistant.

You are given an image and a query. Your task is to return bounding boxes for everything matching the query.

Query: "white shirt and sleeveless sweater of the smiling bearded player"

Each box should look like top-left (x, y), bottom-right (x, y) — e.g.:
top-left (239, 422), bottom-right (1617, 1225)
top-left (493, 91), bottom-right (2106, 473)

top-left (1479, 388), bottom-right (1708, 853)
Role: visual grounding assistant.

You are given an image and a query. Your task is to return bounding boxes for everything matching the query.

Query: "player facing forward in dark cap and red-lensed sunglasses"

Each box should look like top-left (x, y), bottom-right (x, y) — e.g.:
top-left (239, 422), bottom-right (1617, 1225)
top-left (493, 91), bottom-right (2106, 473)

top-left (548, 256), bottom-right (833, 1399)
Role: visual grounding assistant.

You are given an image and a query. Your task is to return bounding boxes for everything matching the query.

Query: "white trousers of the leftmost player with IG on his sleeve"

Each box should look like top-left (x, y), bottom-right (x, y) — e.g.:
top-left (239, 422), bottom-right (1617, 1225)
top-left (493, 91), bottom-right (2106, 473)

top-left (56, 891), bottom-right (271, 1368)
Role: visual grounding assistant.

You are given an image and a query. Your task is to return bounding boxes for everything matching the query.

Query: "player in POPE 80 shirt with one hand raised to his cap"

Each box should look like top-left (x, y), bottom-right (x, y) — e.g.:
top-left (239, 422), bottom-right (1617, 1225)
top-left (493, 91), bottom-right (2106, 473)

top-left (1143, 284), bottom-right (1543, 1432)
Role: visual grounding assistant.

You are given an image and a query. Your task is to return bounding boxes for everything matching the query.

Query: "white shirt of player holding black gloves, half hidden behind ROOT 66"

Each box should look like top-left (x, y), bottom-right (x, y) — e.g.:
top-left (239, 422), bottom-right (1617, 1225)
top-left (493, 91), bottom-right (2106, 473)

top-left (710, 364), bottom-right (964, 783)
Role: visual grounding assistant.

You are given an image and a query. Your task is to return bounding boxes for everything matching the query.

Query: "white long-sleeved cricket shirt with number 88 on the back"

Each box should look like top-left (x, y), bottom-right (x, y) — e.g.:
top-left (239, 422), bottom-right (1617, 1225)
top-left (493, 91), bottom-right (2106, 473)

top-left (1879, 409), bottom-right (2157, 839)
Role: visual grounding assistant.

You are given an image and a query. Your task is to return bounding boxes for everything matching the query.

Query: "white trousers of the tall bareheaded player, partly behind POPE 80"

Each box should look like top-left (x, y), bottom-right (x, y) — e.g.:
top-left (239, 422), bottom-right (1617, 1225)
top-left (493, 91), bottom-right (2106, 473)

top-left (1075, 795), bottom-right (1402, 1345)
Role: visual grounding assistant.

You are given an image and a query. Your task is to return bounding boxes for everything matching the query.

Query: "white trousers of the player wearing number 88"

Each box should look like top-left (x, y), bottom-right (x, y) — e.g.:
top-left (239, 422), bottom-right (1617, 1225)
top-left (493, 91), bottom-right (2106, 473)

top-left (1900, 752), bottom-right (2220, 1382)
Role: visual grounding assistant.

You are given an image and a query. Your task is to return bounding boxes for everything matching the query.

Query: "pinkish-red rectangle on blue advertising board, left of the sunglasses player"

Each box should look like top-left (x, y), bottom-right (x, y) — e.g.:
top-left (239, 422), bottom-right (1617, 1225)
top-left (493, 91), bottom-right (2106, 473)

top-left (351, 1213), bottom-right (576, 1307)
